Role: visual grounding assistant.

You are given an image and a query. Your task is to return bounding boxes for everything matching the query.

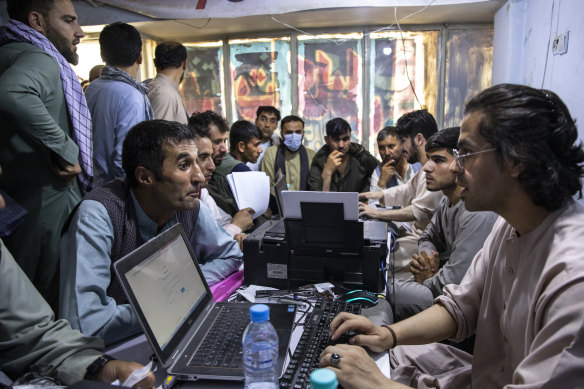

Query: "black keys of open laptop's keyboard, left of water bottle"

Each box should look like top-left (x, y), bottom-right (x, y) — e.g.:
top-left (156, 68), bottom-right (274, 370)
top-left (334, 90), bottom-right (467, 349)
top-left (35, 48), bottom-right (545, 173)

top-left (189, 306), bottom-right (249, 368)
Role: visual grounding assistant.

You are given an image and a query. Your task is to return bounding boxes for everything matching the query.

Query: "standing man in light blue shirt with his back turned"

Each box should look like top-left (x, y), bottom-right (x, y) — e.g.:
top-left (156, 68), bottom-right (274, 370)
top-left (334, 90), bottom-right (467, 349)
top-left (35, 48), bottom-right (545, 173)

top-left (85, 23), bottom-right (154, 186)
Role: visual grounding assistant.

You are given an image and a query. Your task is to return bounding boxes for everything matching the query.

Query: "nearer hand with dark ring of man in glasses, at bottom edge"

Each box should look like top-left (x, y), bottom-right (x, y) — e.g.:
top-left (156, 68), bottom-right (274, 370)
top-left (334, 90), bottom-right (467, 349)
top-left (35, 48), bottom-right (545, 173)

top-left (319, 344), bottom-right (390, 389)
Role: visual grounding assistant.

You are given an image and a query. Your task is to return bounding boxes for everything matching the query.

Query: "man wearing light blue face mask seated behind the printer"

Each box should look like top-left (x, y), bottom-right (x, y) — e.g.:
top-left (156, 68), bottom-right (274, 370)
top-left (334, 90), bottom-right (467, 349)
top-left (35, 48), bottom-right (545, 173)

top-left (261, 115), bottom-right (316, 195)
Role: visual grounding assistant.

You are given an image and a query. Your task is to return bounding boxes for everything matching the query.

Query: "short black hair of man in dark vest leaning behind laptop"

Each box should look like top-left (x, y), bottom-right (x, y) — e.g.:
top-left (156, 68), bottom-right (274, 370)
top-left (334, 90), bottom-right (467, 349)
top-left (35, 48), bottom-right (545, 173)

top-left (122, 120), bottom-right (195, 188)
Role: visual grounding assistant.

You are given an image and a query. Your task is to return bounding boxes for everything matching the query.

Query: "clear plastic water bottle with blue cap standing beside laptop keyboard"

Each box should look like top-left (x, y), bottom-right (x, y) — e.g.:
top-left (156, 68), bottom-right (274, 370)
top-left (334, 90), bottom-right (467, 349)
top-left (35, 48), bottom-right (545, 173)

top-left (243, 304), bottom-right (279, 389)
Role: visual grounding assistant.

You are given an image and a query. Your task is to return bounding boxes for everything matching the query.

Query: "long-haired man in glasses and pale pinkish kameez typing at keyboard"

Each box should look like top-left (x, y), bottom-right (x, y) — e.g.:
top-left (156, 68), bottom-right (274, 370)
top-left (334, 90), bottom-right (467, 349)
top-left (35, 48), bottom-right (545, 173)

top-left (320, 84), bottom-right (584, 388)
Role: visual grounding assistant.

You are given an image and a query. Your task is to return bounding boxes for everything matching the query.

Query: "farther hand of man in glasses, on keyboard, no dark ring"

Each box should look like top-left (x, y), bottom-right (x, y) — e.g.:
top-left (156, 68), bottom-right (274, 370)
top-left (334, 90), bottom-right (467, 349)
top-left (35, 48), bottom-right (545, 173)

top-left (329, 312), bottom-right (393, 352)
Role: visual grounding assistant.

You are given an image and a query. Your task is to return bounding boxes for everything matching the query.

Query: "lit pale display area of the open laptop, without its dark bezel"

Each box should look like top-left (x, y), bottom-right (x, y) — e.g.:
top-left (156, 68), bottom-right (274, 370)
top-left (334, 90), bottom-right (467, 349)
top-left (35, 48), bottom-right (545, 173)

top-left (125, 230), bottom-right (206, 350)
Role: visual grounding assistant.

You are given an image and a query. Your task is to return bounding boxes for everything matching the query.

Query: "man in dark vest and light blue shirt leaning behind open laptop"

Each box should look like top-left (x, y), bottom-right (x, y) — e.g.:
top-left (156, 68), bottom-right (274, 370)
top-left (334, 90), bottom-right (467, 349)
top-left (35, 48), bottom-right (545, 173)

top-left (60, 120), bottom-right (243, 345)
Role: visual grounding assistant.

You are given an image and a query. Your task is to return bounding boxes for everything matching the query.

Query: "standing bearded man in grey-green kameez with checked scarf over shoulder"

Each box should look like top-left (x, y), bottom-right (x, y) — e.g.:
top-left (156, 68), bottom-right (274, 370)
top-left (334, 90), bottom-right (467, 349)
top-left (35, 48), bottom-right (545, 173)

top-left (0, 0), bottom-right (92, 309)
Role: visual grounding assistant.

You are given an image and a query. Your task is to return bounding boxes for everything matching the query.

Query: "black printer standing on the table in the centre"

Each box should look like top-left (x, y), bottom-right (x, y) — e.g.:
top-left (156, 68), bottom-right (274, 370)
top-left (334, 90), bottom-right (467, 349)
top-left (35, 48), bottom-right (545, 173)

top-left (243, 200), bottom-right (387, 292)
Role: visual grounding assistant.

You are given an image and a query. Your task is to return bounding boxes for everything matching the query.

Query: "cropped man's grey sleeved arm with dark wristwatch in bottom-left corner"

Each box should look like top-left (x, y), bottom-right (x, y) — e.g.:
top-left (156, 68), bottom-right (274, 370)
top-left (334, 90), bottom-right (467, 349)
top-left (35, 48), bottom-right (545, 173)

top-left (0, 162), bottom-right (154, 388)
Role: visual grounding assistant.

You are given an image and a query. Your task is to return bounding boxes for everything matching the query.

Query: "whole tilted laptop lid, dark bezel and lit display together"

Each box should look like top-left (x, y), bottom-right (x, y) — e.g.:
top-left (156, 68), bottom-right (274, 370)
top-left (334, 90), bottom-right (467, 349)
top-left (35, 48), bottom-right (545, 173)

top-left (114, 223), bottom-right (213, 365)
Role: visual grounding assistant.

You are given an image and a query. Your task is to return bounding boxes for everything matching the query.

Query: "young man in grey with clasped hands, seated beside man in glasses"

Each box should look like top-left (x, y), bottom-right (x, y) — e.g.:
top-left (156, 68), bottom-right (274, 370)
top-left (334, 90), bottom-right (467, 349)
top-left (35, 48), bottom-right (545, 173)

top-left (390, 127), bottom-right (497, 321)
